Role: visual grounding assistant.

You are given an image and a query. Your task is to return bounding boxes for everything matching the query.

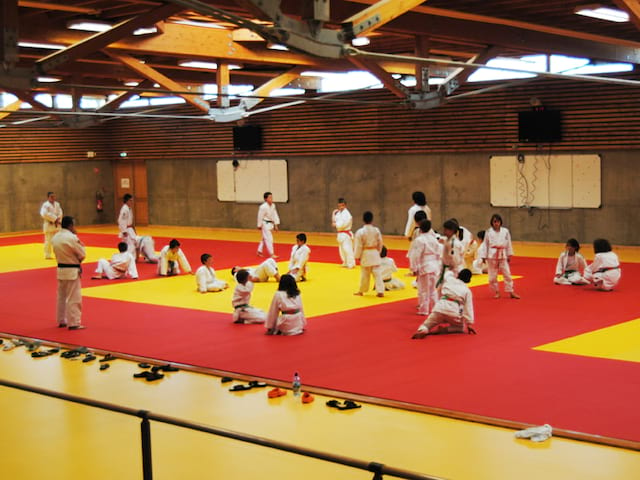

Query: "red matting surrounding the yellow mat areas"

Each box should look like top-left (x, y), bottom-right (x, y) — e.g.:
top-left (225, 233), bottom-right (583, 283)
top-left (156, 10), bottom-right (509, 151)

top-left (0, 235), bottom-right (640, 441)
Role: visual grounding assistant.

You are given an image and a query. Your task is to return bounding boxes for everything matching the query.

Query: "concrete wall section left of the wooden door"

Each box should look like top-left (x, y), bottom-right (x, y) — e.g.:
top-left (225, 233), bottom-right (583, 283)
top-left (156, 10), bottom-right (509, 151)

top-left (0, 161), bottom-right (115, 232)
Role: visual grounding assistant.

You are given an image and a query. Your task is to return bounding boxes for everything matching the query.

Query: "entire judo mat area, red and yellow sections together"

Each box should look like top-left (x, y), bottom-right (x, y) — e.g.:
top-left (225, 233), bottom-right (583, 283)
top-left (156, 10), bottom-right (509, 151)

top-left (0, 227), bottom-right (640, 442)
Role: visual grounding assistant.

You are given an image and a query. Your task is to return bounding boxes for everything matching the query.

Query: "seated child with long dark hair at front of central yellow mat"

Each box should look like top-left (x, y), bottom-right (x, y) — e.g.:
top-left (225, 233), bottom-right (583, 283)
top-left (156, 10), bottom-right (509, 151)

top-left (265, 274), bottom-right (307, 335)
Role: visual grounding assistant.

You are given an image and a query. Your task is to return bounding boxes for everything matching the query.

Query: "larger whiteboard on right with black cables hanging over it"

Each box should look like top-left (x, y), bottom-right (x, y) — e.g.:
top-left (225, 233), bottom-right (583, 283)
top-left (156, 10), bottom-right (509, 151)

top-left (489, 153), bottom-right (601, 208)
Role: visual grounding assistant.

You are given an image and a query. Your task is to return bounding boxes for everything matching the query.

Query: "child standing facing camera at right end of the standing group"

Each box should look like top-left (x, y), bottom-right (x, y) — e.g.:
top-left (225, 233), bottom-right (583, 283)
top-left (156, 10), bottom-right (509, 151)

top-left (478, 213), bottom-right (520, 299)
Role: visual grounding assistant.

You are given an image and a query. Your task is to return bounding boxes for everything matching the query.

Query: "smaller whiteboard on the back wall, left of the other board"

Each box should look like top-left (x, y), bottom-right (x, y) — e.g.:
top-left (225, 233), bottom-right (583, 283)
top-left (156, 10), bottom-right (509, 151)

top-left (216, 160), bottom-right (289, 203)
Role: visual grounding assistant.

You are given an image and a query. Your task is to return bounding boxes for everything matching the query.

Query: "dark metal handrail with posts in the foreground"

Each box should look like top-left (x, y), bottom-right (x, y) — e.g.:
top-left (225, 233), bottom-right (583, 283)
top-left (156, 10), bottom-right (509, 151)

top-left (0, 379), bottom-right (443, 480)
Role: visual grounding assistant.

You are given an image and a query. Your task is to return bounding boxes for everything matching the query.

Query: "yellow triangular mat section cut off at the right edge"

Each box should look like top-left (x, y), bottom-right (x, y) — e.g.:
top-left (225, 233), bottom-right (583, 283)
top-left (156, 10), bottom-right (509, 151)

top-left (534, 318), bottom-right (640, 362)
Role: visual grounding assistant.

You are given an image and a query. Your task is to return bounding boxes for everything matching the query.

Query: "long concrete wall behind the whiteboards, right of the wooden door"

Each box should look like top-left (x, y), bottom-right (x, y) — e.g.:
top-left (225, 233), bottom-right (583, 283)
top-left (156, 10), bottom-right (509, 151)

top-left (147, 152), bottom-right (640, 245)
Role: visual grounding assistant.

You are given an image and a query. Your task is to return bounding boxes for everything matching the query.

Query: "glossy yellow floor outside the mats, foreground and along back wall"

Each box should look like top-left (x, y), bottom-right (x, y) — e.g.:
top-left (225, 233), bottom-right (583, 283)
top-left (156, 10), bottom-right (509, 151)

top-left (0, 227), bottom-right (640, 480)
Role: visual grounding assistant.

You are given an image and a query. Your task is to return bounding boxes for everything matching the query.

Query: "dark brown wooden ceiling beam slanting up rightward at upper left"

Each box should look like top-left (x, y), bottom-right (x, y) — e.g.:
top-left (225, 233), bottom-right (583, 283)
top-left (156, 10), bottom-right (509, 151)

top-left (36, 4), bottom-right (183, 73)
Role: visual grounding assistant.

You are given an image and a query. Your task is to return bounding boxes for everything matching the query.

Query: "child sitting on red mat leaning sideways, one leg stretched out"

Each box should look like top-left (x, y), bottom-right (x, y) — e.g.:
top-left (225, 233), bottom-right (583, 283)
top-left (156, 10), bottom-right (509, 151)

top-left (411, 268), bottom-right (476, 339)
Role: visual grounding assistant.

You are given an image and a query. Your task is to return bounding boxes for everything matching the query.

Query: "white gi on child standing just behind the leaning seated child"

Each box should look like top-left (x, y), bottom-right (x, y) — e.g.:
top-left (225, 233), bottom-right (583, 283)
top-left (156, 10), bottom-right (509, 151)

top-left (409, 230), bottom-right (442, 315)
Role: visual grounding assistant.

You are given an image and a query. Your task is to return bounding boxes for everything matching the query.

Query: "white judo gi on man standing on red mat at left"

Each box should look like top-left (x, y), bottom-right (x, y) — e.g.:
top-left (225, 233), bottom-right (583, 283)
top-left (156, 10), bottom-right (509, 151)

top-left (51, 228), bottom-right (86, 327)
